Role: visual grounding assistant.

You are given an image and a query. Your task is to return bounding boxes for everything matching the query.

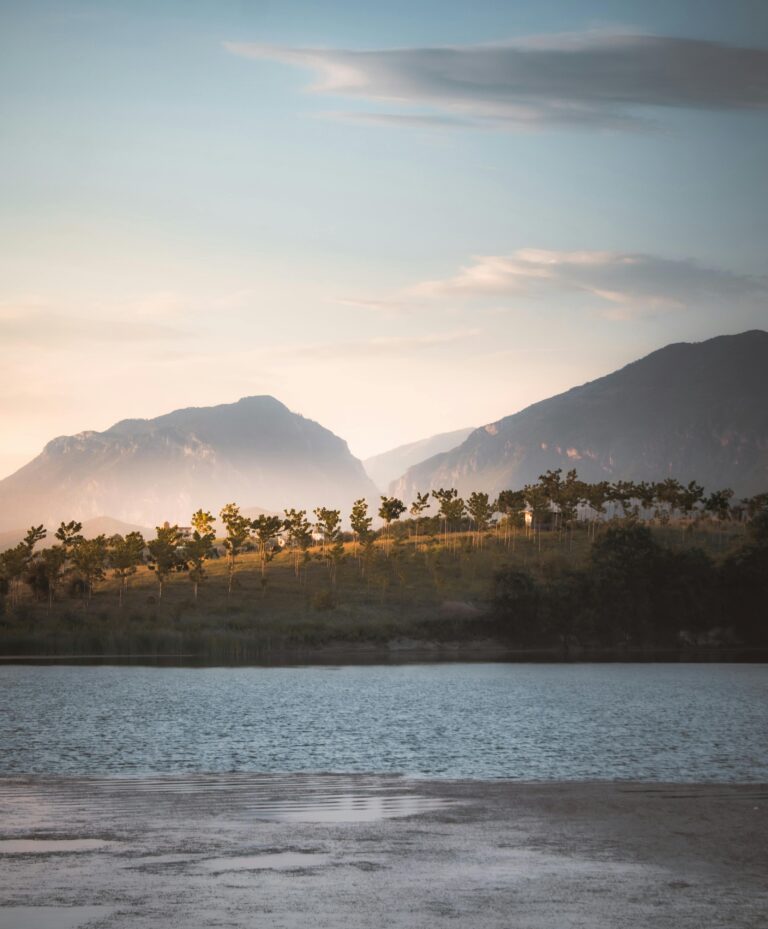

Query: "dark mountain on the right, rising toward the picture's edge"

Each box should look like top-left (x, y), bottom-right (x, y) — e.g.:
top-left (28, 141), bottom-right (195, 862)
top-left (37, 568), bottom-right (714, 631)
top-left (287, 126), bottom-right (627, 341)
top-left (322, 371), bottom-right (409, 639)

top-left (393, 330), bottom-right (768, 500)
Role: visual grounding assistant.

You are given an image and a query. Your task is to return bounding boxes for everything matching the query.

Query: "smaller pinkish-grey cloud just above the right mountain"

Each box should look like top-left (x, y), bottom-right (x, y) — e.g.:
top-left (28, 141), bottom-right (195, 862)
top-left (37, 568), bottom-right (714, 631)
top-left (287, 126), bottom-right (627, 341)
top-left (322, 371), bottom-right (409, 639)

top-left (411, 248), bottom-right (768, 319)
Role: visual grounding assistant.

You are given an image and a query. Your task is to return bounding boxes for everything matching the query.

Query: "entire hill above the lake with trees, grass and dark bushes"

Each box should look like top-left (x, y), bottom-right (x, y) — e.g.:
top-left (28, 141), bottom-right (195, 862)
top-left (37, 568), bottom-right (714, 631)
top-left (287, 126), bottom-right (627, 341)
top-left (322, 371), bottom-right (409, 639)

top-left (0, 470), bottom-right (768, 661)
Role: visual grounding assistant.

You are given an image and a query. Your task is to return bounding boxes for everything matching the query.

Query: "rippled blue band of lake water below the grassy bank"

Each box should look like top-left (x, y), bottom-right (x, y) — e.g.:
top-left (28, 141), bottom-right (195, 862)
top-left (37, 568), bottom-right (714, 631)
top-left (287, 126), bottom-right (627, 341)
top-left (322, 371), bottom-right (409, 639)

top-left (0, 664), bottom-right (768, 782)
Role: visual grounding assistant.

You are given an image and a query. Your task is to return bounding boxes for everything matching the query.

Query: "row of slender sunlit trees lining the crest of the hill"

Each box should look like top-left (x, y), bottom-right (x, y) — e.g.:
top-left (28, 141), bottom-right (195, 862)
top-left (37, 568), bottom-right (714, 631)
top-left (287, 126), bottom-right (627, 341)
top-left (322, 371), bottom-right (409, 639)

top-left (0, 469), bottom-right (768, 608)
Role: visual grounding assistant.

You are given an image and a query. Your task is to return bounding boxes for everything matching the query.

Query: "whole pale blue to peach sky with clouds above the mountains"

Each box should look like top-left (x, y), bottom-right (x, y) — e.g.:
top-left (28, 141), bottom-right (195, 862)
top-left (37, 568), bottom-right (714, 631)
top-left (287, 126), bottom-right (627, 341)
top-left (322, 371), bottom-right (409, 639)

top-left (0, 0), bottom-right (768, 477)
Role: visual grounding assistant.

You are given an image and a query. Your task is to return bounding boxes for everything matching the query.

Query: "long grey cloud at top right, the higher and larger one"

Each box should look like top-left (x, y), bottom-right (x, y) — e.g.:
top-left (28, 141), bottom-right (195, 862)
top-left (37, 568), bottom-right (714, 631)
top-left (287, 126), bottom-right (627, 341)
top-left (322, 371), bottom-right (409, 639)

top-left (225, 32), bottom-right (768, 128)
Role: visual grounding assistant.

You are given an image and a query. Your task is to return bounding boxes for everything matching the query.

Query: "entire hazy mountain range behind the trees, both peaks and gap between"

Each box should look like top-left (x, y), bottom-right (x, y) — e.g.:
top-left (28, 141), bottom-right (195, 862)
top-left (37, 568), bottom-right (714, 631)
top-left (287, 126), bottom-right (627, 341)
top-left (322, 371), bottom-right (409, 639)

top-left (0, 330), bottom-right (768, 537)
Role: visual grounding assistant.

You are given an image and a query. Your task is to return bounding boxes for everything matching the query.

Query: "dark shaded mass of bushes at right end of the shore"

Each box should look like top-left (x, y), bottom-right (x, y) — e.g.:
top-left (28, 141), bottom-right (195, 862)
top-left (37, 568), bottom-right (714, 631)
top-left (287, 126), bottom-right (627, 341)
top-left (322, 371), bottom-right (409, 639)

top-left (493, 509), bottom-right (768, 654)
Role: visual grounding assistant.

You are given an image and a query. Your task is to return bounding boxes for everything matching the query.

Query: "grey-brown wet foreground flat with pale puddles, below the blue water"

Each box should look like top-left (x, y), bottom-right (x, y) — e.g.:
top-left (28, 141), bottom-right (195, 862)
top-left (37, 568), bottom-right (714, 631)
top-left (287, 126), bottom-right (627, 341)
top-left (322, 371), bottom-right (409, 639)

top-left (0, 775), bottom-right (768, 929)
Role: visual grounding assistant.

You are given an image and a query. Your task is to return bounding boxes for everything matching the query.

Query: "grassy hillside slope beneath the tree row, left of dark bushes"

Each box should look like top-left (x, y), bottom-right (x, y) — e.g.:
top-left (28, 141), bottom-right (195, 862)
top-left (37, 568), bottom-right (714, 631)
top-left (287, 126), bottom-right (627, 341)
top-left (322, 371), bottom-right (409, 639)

top-left (0, 525), bottom-right (743, 660)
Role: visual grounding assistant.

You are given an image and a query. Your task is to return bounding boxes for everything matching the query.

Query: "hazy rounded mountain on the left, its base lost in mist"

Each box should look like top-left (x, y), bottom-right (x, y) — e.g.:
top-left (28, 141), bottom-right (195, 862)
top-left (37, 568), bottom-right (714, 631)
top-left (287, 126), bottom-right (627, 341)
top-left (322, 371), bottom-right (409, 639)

top-left (0, 397), bottom-right (376, 530)
